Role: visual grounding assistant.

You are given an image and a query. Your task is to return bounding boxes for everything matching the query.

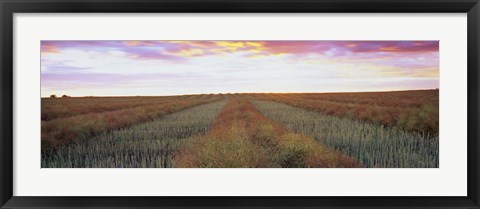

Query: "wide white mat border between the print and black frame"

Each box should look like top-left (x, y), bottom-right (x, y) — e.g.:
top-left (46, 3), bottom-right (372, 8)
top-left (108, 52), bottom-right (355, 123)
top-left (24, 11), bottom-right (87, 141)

top-left (14, 14), bottom-right (467, 196)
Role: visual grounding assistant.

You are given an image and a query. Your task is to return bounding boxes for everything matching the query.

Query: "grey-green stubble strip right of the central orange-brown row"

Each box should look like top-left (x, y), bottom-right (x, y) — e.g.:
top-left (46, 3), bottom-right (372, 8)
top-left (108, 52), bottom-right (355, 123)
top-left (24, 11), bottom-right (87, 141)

top-left (253, 101), bottom-right (439, 168)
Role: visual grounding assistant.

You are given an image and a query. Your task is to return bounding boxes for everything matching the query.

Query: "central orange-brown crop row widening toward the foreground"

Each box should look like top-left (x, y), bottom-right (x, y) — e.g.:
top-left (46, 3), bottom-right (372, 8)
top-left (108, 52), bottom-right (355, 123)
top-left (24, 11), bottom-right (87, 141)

top-left (174, 99), bottom-right (361, 168)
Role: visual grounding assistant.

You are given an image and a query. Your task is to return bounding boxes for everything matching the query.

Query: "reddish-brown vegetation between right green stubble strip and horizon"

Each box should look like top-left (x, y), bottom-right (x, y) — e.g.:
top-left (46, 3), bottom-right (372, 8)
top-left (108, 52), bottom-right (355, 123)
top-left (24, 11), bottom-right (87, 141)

top-left (251, 89), bottom-right (439, 135)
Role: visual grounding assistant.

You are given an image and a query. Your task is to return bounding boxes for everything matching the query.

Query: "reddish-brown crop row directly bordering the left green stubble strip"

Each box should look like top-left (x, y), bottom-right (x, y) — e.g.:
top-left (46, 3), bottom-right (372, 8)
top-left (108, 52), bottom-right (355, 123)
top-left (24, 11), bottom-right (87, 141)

top-left (41, 95), bottom-right (222, 154)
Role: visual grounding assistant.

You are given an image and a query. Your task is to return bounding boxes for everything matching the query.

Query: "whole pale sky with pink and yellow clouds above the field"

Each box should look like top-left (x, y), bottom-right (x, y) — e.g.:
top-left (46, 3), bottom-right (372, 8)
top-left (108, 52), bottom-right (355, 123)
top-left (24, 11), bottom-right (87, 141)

top-left (40, 41), bottom-right (439, 97)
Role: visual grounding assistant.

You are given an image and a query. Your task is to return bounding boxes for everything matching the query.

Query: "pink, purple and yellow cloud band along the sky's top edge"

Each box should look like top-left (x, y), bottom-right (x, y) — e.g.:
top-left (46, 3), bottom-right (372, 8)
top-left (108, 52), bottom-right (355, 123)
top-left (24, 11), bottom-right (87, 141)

top-left (42, 41), bottom-right (439, 62)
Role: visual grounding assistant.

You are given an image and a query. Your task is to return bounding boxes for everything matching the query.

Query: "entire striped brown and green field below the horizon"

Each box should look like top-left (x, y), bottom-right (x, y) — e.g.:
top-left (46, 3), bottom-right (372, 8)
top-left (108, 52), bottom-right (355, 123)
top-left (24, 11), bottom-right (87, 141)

top-left (41, 89), bottom-right (439, 168)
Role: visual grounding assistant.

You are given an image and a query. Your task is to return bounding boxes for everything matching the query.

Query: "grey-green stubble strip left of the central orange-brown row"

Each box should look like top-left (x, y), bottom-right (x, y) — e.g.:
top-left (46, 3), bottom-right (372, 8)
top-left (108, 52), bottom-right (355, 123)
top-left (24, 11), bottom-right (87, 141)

top-left (42, 101), bottom-right (226, 168)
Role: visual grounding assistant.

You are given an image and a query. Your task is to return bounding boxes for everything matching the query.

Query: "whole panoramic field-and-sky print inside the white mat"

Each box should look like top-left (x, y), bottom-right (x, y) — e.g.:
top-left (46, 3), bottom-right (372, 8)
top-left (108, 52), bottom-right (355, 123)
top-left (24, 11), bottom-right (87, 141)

top-left (39, 40), bottom-right (439, 168)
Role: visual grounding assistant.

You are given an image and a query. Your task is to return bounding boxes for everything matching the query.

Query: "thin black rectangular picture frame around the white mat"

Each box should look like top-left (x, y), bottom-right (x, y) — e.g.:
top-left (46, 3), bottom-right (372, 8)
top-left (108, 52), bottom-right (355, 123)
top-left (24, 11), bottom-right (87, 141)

top-left (0, 0), bottom-right (480, 209)
